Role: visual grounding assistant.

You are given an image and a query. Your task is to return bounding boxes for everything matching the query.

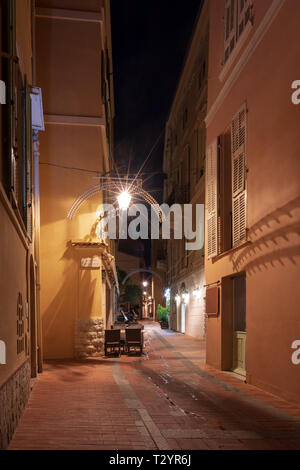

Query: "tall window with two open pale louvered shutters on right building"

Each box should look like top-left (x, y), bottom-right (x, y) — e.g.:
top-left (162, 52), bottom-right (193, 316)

top-left (206, 104), bottom-right (247, 258)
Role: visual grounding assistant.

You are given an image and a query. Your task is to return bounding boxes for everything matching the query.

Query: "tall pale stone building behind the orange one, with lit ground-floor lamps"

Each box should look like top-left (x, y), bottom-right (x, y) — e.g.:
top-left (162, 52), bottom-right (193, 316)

top-left (163, 2), bottom-right (209, 339)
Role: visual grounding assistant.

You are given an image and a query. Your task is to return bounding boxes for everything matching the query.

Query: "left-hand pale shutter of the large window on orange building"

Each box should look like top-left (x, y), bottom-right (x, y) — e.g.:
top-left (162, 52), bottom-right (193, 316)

top-left (206, 139), bottom-right (218, 259)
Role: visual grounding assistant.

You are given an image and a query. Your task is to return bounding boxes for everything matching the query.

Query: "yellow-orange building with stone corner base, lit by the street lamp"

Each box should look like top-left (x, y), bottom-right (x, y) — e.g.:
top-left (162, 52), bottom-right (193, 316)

top-left (35, 0), bottom-right (117, 359)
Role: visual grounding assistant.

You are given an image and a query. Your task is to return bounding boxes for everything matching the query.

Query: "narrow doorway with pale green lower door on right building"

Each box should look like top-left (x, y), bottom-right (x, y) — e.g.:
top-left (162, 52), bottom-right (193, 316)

top-left (233, 276), bottom-right (246, 375)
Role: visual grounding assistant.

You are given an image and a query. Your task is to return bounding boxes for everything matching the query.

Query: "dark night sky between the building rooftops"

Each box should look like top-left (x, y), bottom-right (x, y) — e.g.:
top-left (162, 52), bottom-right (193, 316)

top-left (111, 0), bottom-right (201, 203)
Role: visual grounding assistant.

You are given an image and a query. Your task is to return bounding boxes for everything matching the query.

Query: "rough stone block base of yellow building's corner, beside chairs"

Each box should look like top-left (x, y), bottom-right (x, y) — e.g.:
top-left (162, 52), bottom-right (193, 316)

top-left (75, 318), bottom-right (104, 359)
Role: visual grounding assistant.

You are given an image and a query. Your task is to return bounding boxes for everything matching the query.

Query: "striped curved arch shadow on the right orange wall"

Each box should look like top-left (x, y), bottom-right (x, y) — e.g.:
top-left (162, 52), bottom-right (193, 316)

top-left (230, 197), bottom-right (300, 275)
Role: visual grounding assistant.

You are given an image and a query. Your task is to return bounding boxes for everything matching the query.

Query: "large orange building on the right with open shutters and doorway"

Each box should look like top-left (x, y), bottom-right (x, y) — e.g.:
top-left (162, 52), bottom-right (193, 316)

top-left (205, 0), bottom-right (300, 403)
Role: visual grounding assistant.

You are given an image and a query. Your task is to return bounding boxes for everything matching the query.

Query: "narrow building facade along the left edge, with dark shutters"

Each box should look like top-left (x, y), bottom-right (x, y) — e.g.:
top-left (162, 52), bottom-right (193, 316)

top-left (0, 0), bottom-right (43, 449)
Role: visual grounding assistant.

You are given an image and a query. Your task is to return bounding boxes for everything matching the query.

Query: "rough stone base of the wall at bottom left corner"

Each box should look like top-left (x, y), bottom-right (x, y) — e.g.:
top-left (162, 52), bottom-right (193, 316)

top-left (0, 361), bottom-right (30, 449)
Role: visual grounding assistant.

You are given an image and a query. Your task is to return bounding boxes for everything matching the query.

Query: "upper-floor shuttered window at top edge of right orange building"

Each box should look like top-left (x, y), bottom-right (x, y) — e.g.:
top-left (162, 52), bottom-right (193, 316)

top-left (224, 0), bottom-right (252, 63)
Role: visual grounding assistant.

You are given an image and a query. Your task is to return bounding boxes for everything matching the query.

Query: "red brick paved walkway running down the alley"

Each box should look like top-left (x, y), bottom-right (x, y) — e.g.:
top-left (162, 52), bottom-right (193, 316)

top-left (10, 324), bottom-right (300, 450)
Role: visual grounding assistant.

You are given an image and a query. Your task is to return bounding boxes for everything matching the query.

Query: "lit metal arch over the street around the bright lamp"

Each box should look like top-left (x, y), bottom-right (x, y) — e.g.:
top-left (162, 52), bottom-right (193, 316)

top-left (67, 177), bottom-right (163, 220)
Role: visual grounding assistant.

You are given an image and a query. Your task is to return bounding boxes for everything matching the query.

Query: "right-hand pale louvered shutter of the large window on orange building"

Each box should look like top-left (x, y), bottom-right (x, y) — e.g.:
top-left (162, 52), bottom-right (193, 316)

top-left (231, 105), bottom-right (247, 246)
